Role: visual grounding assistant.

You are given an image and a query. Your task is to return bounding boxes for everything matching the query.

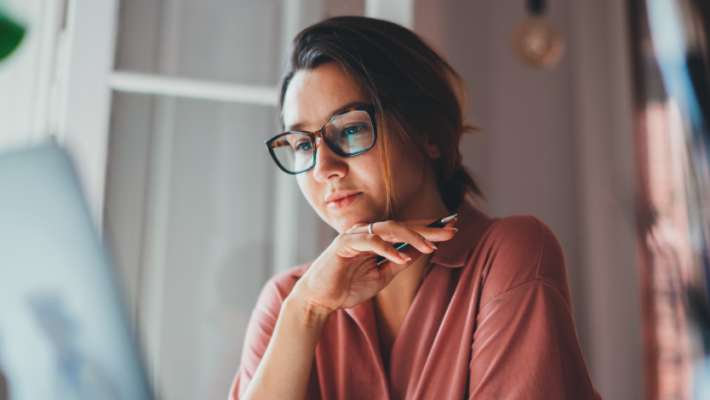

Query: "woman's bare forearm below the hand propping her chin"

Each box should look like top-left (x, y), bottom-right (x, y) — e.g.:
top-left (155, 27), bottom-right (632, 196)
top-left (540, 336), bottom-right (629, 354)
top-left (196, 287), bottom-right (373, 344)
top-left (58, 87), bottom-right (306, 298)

top-left (244, 288), bottom-right (328, 400)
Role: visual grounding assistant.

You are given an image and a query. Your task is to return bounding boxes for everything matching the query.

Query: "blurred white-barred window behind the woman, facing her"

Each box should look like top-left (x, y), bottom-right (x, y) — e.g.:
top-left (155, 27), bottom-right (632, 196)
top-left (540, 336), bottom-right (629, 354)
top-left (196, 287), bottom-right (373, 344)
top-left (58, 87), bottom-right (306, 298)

top-left (104, 0), bottom-right (332, 399)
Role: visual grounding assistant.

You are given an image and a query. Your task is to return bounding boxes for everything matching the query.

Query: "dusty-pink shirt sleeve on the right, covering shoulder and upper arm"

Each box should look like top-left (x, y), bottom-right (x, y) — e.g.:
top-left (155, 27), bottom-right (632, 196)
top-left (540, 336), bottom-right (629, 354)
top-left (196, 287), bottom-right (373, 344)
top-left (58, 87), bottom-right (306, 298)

top-left (469, 217), bottom-right (600, 400)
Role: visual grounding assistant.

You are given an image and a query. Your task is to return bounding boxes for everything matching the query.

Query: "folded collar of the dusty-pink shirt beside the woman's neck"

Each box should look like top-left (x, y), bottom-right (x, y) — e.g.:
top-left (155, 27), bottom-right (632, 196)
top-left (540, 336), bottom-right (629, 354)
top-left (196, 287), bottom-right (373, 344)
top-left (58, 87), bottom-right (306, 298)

top-left (429, 200), bottom-right (494, 268)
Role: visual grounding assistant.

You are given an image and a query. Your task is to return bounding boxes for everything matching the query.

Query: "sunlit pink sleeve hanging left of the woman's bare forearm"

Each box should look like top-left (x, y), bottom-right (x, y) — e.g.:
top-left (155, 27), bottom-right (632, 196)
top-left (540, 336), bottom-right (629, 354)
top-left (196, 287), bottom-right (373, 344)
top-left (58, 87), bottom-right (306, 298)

top-left (229, 273), bottom-right (297, 400)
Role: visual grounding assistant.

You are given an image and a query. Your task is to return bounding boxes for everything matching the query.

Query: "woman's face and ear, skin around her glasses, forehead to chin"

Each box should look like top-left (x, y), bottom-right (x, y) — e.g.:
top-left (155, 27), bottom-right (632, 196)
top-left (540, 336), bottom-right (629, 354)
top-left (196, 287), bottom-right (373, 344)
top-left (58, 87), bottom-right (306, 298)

top-left (283, 63), bottom-right (436, 232)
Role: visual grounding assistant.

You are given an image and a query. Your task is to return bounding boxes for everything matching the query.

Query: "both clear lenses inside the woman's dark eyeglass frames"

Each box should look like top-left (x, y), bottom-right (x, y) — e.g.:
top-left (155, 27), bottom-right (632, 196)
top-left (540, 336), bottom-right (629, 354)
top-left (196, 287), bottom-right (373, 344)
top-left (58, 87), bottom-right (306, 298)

top-left (272, 111), bottom-right (375, 173)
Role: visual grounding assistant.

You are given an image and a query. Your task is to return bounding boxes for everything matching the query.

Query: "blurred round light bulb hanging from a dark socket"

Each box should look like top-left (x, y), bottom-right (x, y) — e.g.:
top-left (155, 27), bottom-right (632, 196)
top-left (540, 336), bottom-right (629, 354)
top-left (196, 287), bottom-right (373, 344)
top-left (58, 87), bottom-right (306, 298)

top-left (513, 0), bottom-right (565, 68)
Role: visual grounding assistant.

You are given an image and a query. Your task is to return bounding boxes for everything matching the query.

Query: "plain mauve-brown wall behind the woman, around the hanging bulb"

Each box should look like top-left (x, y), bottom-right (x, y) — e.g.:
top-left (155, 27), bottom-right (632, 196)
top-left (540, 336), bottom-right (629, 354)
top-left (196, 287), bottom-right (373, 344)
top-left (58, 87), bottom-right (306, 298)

top-left (415, 0), bottom-right (641, 399)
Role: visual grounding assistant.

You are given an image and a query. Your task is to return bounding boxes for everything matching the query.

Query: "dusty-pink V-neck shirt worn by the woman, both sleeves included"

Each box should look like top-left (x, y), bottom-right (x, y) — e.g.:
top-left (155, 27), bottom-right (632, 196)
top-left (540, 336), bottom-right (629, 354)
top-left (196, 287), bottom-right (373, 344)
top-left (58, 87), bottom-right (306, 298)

top-left (231, 201), bottom-right (600, 400)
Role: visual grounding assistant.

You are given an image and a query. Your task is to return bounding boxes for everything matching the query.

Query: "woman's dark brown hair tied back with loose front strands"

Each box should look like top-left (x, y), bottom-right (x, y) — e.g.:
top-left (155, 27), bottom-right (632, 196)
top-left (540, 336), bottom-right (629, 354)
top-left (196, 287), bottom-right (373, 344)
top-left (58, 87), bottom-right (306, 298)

top-left (281, 17), bottom-right (483, 218)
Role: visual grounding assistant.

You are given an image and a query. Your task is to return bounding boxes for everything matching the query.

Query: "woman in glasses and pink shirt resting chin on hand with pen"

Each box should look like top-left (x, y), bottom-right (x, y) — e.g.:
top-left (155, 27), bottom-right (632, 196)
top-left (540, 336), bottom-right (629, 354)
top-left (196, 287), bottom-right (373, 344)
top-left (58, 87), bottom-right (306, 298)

top-left (231, 17), bottom-right (599, 400)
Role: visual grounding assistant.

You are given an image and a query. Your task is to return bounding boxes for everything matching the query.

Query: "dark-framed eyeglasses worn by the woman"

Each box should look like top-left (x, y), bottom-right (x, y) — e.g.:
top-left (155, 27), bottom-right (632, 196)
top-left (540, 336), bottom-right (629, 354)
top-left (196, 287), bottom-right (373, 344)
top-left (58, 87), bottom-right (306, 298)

top-left (264, 105), bottom-right (377, 175)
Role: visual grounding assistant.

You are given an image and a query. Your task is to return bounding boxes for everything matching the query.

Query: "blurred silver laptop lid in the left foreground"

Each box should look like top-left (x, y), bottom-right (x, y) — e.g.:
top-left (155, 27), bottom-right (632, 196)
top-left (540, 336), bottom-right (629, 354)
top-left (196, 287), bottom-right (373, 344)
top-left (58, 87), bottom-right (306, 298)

top-left (0, 144), bottom-right (152, 400)
